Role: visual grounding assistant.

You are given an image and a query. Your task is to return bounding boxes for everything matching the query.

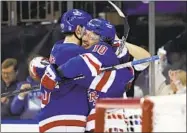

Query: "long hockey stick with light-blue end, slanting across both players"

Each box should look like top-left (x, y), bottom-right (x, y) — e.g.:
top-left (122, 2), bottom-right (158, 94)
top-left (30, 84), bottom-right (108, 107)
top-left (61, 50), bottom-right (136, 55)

top-left (1, 55), bottom-right (159, 98)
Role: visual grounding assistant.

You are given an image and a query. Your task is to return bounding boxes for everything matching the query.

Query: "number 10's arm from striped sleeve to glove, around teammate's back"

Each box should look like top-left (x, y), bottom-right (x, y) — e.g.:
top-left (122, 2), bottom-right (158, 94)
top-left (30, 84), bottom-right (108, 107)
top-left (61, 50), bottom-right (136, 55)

top-left (41, 53), bottom-right (105, 90)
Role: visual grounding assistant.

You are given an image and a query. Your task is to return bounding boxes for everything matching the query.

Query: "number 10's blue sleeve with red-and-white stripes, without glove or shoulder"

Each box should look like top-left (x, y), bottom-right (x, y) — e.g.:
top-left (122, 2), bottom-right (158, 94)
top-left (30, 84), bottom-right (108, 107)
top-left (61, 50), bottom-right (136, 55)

top-left (57, 53), bottom-right (102, 78)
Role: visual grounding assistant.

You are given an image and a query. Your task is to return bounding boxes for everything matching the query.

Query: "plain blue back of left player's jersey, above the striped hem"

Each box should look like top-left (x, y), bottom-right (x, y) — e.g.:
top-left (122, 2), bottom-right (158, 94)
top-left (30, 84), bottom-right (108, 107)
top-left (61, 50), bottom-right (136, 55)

top-left (39, 42), bottom-right (88, 124)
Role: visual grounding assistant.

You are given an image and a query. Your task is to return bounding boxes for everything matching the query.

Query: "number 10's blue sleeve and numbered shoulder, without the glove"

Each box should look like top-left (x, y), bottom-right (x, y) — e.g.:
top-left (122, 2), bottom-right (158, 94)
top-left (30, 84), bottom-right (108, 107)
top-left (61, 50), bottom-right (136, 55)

top-left (57, 44), bottom-right (115, 78)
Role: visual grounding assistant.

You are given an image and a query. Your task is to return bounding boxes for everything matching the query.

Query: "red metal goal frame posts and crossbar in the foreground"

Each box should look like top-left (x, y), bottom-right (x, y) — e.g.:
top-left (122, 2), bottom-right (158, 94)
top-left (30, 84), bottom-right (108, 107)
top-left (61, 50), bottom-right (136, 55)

top-left (95, 98), bottom-right (153, 132)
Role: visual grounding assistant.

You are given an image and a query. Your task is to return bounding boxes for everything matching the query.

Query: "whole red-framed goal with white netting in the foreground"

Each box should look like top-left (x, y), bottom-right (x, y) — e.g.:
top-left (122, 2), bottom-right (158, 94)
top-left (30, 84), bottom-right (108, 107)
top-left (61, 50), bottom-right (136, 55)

top-left (95, 94), bottom-right (186, 132)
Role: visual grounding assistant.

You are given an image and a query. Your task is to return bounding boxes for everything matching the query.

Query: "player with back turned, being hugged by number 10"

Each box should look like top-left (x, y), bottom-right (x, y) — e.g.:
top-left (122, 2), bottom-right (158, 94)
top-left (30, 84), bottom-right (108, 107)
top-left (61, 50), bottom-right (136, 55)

top-left (38, 9), bottom-right (91, 132)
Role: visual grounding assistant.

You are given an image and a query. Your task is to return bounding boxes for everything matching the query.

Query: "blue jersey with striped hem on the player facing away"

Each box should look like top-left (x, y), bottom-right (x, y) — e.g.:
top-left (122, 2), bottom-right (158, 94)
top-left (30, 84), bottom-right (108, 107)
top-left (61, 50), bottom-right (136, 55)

top-left (38, 41), bottom-right (89, 132)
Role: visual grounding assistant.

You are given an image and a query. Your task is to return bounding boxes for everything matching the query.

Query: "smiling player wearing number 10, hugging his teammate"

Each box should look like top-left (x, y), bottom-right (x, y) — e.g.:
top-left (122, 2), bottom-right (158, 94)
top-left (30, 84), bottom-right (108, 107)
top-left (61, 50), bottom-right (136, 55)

top-left (41, 19), bottom-right (134, 130)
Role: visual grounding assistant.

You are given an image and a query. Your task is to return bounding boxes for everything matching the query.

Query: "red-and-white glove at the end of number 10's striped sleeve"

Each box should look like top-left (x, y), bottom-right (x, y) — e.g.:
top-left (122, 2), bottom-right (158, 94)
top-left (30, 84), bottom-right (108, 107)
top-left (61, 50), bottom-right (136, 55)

top-left (41, 65), bottom-right (61, 90)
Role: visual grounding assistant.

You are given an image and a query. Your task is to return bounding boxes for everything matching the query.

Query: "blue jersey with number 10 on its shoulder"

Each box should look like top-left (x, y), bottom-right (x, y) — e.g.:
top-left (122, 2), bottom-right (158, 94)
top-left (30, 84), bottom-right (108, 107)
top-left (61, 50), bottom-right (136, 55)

top-left (59, 43), bottom-right (134, 131)
